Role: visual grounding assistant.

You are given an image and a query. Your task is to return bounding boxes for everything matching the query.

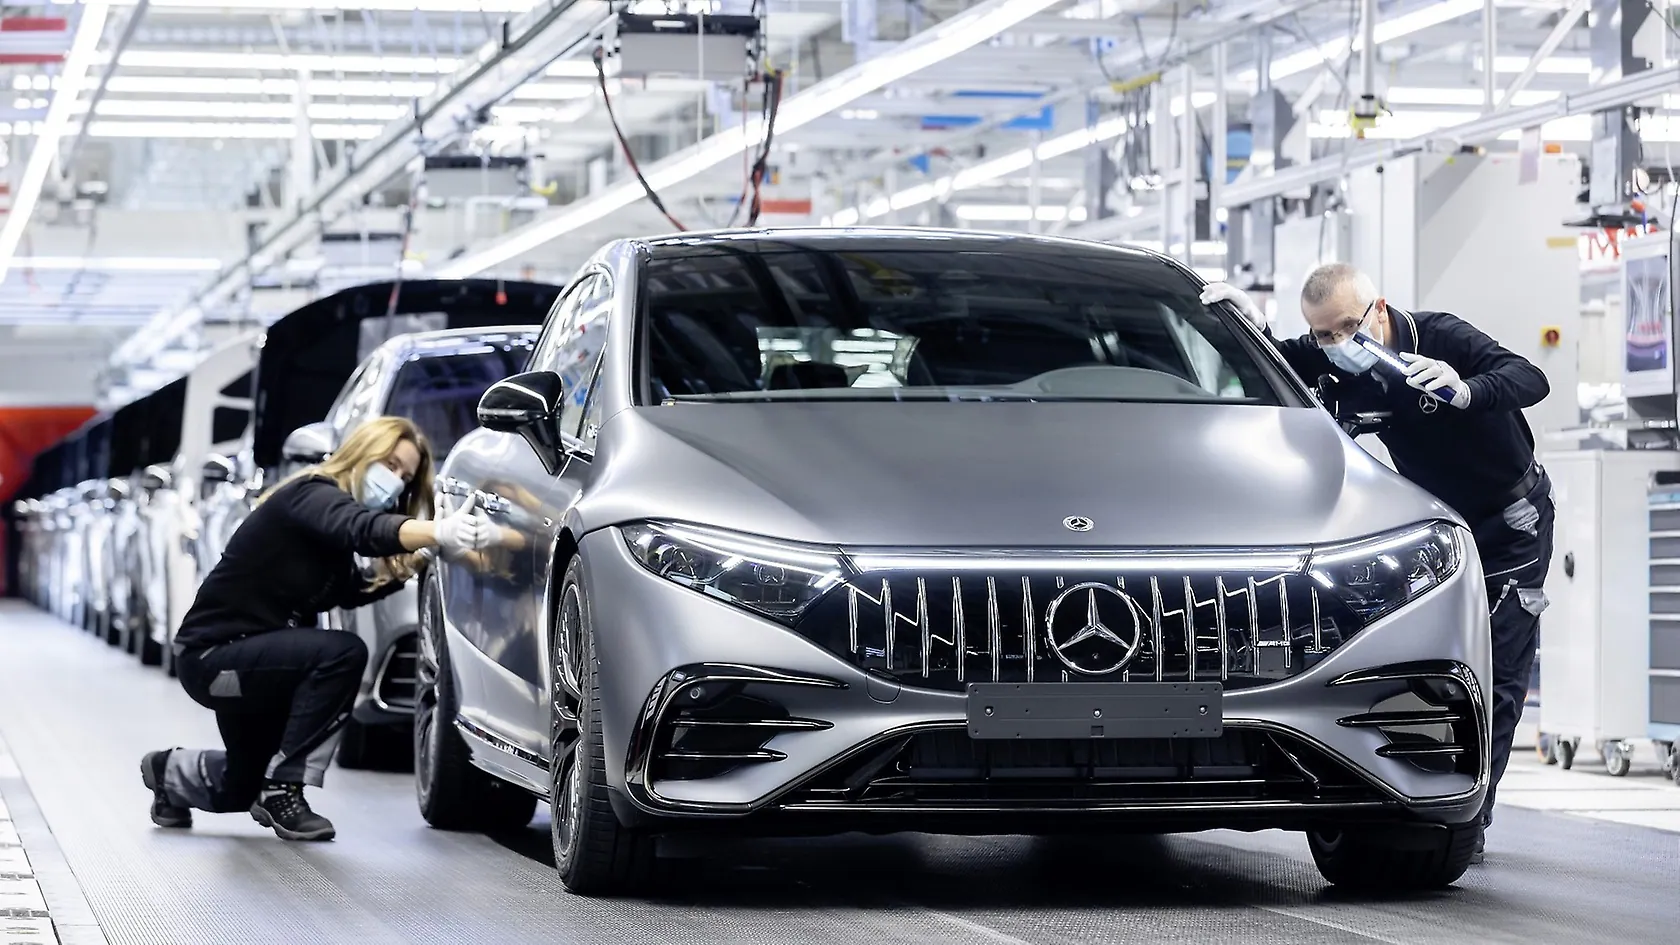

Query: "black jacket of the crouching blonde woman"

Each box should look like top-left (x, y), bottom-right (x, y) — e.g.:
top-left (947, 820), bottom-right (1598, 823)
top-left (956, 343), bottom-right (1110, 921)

top-left (175, 476), bottom-right (408, 649)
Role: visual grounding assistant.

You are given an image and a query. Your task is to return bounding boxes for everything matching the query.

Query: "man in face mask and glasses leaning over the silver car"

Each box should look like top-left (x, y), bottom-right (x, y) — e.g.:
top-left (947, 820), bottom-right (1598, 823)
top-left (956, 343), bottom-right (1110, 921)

top-left (1201, 262), bottom-right (1554, 863)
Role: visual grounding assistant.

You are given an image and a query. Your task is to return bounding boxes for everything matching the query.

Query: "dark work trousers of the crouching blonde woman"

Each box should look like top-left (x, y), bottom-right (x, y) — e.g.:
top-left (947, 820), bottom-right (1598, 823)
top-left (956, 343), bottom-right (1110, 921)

top-left (163, 627), bottom-right (368, 812)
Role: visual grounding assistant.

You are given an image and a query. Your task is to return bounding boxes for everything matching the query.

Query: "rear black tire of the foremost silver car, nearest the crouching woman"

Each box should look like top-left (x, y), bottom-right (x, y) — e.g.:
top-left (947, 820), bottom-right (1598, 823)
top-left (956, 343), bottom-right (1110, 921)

top-left (413, 580), bottom-right (536, 831)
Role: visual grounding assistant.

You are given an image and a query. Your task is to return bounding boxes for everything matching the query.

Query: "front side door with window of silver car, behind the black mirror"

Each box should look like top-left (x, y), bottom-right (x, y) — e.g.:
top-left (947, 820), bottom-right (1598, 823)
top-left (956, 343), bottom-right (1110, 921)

top-left (480, 271), bottom-right (613, 755)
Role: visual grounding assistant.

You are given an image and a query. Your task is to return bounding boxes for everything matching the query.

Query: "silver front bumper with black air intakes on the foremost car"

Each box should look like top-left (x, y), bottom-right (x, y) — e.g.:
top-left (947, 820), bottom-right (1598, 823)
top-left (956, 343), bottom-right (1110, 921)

top-left (583, 528), bottom-right (1492, 832)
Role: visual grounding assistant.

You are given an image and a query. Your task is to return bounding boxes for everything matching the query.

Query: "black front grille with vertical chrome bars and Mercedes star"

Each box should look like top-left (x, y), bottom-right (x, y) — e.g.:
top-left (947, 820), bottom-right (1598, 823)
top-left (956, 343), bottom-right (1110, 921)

top-left (796, 572), bottom-right (1356, 689)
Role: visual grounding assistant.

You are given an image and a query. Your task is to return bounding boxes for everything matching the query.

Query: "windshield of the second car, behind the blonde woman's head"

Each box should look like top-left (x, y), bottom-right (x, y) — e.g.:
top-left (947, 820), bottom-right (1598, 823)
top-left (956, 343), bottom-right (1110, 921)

top-left (385, 345), bottom-right (531, 462)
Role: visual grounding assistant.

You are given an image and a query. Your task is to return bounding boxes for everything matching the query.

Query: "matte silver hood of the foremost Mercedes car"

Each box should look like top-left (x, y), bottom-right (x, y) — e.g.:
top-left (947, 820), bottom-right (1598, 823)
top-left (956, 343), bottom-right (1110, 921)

top-left (578, 402), bottom-right (1455, 548)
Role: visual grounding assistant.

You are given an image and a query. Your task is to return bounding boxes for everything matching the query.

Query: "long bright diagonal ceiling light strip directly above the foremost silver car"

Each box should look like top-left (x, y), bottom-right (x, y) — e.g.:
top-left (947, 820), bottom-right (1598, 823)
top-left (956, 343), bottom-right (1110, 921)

top-left (437, 0), bottom-right (1061, 279)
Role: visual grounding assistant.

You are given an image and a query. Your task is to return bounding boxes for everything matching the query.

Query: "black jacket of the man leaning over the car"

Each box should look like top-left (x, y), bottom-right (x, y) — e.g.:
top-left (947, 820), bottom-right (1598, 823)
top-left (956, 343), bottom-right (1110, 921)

top-left (1273, 308), bottom-right (1551, 525)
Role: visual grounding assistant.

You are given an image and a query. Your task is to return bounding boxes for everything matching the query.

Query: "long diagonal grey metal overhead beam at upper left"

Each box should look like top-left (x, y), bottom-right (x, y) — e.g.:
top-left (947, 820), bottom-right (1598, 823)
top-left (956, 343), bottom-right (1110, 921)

top-left (113, 0), bottom-right (608, 365)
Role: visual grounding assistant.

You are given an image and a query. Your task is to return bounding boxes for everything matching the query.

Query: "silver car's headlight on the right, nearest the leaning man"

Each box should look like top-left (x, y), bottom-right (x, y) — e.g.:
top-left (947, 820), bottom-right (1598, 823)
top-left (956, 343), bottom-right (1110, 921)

top-left (1307, 521), bottom-right (1463, 624)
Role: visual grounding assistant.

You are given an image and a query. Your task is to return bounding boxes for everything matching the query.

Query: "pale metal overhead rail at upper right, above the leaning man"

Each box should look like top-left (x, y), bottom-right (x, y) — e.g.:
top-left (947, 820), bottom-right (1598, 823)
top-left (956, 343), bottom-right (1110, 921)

top-left (1220, 66), bottom-right (1680, 207)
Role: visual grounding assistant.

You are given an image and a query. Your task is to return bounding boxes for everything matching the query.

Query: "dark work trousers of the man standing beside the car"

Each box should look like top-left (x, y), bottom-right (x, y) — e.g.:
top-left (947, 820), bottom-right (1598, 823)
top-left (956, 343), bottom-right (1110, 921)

top-left (1472, 473), bottom-right (1557, 826)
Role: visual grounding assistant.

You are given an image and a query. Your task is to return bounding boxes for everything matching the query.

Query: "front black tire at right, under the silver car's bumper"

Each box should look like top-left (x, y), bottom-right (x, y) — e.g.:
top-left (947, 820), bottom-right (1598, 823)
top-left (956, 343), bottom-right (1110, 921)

top-left (1307, 821), bottom-right (1482, 893)
